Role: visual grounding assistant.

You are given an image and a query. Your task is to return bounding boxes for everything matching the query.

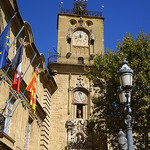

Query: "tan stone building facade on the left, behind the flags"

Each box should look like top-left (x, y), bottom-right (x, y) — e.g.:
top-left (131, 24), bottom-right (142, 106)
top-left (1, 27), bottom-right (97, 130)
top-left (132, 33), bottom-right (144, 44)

top-left (0, 0), bottom-right (57, 150)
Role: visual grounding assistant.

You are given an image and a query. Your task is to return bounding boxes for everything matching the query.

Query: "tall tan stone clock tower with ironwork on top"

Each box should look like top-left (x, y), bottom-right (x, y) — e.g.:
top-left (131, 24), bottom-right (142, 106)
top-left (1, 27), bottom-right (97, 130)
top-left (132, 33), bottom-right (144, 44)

top-left (48, 0), bottom-right (105, 150)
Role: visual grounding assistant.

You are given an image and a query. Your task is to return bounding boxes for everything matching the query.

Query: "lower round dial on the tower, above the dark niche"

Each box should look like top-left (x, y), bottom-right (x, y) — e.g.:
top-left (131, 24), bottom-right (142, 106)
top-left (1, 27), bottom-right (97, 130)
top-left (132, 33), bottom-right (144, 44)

top-left (74, 91), bottom-right (87, 103)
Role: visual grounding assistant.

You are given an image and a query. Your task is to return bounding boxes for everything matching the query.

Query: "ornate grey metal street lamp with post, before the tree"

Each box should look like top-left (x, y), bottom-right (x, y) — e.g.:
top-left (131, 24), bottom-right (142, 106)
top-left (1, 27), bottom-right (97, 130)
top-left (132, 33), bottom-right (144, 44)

top-left (119, 59), bottom-right (133, 150)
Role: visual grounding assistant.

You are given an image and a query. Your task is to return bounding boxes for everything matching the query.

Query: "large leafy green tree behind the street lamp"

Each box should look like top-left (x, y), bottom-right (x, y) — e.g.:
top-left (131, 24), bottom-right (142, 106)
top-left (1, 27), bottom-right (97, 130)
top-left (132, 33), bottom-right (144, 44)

top-left (87, 31), bottom-right (150, 150)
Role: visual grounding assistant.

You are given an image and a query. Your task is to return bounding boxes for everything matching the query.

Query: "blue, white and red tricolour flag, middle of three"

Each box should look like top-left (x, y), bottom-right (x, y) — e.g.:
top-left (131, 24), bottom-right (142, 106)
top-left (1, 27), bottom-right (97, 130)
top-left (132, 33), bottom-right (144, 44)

top-left (10, 40), bottom-right (24, 93)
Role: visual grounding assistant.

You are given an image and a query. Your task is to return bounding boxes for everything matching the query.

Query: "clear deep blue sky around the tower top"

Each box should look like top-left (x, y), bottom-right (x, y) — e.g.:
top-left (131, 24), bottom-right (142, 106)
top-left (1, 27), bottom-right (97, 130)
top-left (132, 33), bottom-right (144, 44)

top-left (17, 0), bottom-right (150, 64)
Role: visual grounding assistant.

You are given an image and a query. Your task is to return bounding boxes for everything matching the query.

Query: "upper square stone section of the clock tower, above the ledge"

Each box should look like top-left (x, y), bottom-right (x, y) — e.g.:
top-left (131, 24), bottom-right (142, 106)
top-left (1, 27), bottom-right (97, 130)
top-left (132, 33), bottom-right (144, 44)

top-left (57, 14), bottom-right (104, 65)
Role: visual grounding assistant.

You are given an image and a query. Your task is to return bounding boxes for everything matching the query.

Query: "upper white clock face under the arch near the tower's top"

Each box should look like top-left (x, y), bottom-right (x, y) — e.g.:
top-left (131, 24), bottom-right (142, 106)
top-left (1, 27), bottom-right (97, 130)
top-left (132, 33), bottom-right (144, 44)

top-left (73, 31), bottom-right (88, 46)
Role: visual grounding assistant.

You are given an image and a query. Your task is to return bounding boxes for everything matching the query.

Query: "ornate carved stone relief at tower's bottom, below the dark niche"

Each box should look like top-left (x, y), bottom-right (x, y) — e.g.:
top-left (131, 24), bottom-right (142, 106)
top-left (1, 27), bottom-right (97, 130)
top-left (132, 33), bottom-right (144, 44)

top-left (66, 119), bottom-right (92, 150)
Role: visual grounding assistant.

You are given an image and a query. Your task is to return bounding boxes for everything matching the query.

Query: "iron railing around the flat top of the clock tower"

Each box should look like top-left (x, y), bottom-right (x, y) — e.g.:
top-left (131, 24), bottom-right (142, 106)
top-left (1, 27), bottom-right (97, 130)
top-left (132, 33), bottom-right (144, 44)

top-left (60, 8), bottom-right (102, 17)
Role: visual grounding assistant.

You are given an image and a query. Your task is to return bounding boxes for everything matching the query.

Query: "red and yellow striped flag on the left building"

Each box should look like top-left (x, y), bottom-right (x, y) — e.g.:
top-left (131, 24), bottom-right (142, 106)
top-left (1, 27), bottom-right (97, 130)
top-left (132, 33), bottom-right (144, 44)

top-left (26, 69), bottom-right (37, 114)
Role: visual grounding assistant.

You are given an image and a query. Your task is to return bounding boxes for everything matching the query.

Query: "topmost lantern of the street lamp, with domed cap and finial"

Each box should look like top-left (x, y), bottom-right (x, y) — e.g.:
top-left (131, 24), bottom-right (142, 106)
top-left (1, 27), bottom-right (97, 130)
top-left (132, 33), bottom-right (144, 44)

top-left (119, 59), bottom-right (133, 88)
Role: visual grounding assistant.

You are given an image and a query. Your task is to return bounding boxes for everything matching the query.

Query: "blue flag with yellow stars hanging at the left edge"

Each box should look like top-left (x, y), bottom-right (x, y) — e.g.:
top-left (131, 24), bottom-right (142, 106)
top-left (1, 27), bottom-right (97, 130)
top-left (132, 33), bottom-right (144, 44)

top-left (0, 13), bottom-right (16, 69)
